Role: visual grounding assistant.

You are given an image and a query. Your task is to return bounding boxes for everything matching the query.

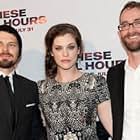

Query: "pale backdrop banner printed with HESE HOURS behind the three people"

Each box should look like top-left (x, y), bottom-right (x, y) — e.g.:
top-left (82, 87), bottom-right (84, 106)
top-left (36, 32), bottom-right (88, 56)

top-left (0, 0), bottom-right (130, 81)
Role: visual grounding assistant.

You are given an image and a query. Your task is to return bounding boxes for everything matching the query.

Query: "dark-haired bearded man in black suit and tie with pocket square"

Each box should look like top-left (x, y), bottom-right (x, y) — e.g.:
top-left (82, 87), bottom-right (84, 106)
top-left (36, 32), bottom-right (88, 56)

top-left (0, 25), bottom-right (47, 140)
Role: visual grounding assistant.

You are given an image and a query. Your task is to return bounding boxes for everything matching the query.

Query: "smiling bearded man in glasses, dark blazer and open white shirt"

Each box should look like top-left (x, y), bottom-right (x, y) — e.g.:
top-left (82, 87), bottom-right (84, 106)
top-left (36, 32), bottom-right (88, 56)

top-left (107, 1), bottom-right (140, 140)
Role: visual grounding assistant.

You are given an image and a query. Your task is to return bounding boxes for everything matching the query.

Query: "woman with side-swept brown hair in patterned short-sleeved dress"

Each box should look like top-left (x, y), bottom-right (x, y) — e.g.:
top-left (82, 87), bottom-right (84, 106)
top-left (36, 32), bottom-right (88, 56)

top-left (38, 23), bottom-right (112, 140)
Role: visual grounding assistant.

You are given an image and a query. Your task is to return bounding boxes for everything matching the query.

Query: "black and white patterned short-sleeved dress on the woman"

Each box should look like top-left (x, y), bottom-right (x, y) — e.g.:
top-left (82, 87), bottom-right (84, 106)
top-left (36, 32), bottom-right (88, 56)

top-left (38, 73), bottom-right (110, 140)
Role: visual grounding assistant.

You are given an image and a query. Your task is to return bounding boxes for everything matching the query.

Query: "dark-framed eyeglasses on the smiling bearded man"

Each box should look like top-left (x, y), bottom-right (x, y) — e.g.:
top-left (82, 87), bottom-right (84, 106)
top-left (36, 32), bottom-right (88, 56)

top-left (118, 20), bottom-right (140, 31)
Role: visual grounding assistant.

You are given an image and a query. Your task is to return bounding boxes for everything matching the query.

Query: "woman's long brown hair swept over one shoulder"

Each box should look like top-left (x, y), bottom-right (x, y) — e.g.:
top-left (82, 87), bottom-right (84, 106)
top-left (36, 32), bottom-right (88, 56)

top-left (45, 23), bottom-right (83, 78)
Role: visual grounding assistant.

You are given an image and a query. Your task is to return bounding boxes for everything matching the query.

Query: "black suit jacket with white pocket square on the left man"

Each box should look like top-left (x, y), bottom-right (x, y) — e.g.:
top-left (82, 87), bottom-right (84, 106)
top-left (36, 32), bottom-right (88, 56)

top-left (0, 74), bottom-right (46, 140)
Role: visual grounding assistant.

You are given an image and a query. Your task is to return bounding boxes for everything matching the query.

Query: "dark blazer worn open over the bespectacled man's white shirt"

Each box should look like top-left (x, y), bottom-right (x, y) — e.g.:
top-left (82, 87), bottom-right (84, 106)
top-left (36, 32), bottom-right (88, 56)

top-left (107, 61), bottom-right (125, 140)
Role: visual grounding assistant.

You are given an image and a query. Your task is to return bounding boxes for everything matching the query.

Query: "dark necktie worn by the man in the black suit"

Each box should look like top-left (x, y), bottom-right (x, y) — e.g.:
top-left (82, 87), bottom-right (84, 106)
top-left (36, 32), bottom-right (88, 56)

top-left (4, 76), bottom-right (15, 130)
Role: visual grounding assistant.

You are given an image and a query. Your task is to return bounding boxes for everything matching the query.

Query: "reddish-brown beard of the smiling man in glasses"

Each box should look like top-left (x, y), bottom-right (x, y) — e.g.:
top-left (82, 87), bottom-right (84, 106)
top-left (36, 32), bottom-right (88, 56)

top-left (121, 33), bottom-right (140, 52)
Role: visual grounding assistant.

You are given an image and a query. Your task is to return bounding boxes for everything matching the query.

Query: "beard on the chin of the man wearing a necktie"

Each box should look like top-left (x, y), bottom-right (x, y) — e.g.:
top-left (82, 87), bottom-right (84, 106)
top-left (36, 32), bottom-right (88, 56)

top-left (0, 59), bottom-right (16, 68)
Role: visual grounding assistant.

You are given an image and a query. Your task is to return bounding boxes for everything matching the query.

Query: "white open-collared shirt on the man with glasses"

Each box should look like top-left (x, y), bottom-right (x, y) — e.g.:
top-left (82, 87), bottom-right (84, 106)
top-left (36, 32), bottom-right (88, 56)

top-left (122, 61), bottom-right (140, 140)
